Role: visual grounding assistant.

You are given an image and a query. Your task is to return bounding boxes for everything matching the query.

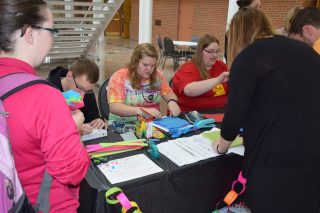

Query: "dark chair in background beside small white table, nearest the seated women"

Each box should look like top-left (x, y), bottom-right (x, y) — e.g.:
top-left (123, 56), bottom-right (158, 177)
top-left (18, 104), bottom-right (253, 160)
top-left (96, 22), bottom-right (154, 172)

top-left (162, 37), bottom-right (185, 70)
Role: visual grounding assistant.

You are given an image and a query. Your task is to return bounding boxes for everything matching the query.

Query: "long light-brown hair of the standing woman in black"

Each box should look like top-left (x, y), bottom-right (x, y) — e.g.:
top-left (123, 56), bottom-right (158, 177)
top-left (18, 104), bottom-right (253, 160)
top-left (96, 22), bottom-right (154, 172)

top-left (228, 7), bottom-right (275, 67)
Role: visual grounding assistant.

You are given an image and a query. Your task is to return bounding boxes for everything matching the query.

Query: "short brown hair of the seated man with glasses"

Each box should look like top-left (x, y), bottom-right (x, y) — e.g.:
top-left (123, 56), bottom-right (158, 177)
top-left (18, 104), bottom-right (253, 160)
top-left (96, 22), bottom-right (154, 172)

top-left (69, 58), bottom-right (99, 84)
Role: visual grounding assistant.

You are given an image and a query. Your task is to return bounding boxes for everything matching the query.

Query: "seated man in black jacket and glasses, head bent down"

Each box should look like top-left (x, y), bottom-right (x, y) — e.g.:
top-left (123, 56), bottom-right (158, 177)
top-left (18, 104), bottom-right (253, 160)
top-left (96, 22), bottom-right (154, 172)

top-left (48, 59), bottom-right (106, 135)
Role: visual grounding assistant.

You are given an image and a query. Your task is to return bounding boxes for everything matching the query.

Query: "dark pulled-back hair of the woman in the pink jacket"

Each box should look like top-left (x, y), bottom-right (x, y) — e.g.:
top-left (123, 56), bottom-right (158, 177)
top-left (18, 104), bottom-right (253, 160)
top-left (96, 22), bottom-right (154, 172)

top-left (0, 0), bottom-right (47, 53)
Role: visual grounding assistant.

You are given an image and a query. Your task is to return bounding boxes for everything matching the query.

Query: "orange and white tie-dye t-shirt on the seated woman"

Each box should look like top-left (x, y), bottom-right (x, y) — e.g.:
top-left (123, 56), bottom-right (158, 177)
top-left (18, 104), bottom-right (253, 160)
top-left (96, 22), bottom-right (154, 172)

top-left (107, 68), bottom-right (172, 123)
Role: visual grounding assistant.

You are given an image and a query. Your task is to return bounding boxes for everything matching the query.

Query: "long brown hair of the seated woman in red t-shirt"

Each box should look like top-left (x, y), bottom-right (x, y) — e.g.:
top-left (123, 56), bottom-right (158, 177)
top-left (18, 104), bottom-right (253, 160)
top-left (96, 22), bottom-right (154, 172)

top-left (192, 34), bottom-right (219, 80)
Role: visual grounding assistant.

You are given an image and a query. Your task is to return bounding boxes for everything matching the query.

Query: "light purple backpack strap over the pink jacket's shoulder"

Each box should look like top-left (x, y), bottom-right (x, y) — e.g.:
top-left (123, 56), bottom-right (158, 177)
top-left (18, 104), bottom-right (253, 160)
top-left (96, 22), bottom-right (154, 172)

top-left (0, 73), bottom-right (52, 101)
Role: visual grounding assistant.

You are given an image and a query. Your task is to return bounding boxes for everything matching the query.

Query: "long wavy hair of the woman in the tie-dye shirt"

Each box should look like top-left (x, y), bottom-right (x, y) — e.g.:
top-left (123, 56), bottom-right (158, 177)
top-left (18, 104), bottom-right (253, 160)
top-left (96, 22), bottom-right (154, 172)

top-left (128, 43), bottom-right (159, 89)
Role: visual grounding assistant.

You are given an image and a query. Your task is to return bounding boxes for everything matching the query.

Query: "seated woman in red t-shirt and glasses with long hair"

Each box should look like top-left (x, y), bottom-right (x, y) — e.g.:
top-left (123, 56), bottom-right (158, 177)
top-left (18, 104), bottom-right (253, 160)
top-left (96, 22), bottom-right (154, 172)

top-left (172, 34), bottom-right (229, 112)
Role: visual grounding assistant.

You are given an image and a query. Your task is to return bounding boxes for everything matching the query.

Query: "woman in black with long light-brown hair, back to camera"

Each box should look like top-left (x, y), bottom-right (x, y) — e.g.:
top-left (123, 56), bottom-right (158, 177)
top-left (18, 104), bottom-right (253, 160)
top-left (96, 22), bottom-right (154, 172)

top-left (213, 7), bottom-right (320, 213)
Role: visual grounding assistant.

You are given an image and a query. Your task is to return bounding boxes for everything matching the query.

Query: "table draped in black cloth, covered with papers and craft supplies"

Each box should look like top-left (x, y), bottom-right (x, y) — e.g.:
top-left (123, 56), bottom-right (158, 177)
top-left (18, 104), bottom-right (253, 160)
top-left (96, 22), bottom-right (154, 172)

top-left (78, 125), bottom-right (242, 213)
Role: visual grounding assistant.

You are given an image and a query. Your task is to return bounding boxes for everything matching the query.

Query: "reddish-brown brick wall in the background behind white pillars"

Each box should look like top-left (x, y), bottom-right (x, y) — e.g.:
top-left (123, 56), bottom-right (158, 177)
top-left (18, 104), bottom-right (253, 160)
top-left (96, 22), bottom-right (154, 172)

top-left (130, 0), bottom-right (315, 49)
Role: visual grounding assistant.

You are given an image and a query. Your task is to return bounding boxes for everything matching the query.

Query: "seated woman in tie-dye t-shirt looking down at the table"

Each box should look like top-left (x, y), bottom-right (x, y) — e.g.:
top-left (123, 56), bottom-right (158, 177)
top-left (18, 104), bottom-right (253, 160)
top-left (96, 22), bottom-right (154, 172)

top-left (107, 43), bottom-right (180, 123)
